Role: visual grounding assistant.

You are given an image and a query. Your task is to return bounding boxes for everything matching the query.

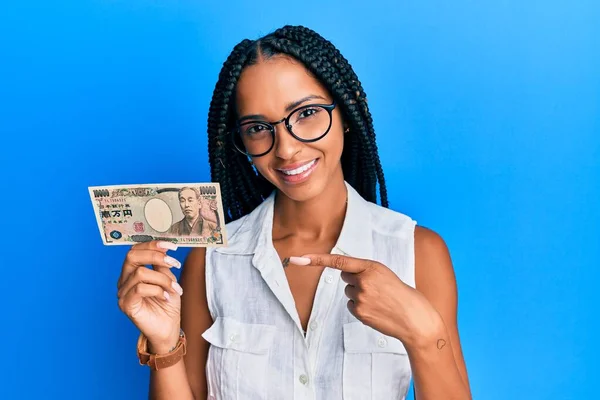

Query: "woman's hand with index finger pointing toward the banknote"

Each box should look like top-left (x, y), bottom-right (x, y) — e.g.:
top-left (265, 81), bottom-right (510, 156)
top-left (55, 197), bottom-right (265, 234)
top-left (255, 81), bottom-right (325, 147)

top-left (290, 254), bottom-right (443, 346)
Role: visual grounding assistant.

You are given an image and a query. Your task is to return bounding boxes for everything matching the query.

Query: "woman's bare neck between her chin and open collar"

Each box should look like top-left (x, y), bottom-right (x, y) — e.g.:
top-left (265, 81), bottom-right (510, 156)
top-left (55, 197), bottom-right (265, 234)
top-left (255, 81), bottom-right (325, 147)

top-left (273, 168), bottom-right (347, 240)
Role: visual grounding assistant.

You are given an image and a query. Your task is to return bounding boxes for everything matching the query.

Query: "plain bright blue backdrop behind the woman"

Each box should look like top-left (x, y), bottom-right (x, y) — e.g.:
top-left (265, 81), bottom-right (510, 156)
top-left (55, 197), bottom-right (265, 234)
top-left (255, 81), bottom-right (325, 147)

top-left (0, 0), bottom-right (600, 400)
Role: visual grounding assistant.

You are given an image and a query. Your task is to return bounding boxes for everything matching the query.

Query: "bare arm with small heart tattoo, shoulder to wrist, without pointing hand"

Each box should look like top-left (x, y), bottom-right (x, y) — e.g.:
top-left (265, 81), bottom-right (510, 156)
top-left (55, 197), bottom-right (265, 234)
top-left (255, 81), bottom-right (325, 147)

top-left (409, 226), bottom-right (471, 400)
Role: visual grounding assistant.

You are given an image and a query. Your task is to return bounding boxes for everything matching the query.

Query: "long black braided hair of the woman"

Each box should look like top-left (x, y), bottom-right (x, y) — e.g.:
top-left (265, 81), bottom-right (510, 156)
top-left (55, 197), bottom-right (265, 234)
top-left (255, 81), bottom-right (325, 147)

top-left (208, 25), bottom-right (388, 222)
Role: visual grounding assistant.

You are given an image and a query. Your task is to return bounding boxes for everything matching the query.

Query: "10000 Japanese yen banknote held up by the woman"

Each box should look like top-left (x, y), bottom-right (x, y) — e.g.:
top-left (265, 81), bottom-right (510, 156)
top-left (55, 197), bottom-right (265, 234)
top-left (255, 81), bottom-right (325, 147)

top-left (88, 183), bottom-right (227, 247)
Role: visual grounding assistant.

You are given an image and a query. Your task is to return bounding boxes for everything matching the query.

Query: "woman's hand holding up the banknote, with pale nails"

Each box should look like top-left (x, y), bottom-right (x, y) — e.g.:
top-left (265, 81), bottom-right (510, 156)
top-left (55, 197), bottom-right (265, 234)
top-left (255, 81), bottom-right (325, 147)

top-left (117, 241), bottom-right (183, 354)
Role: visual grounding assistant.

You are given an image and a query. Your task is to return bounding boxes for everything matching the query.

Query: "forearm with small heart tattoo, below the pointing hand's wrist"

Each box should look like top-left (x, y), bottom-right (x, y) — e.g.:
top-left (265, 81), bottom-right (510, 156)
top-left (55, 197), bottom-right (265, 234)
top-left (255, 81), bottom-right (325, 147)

top-left (406, 323), bottom-right (471, 400)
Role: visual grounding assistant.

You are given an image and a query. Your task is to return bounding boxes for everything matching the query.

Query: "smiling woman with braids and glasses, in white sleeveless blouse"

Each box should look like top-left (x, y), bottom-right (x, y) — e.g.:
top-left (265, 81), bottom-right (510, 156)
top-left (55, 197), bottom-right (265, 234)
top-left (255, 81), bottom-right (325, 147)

top-left (118, 26), bottom-right (470, 400)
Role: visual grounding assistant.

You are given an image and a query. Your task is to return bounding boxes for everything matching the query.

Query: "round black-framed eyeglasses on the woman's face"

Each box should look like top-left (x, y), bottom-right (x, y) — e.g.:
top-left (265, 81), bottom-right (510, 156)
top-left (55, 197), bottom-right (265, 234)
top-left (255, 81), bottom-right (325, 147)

top-left (232, 102), bottom-right (336, 157)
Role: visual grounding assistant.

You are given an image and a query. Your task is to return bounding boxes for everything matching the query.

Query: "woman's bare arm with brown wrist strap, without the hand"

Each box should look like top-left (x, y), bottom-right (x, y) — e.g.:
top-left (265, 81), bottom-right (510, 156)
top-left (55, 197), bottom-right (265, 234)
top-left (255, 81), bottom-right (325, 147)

top-left (150, 248), bottom-right (213, 400)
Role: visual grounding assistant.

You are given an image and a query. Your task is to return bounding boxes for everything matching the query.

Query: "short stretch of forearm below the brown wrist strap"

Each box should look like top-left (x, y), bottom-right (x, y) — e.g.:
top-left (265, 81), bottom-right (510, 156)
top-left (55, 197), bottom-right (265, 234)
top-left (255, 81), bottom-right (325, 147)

top-left (149, 359), bottom-right (197, 400)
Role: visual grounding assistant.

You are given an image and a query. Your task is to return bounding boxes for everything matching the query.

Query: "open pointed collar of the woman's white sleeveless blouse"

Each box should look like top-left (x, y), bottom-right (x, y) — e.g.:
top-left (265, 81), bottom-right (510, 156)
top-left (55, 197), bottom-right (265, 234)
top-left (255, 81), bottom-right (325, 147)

top-left (215, 182), bottom-right (373, 259)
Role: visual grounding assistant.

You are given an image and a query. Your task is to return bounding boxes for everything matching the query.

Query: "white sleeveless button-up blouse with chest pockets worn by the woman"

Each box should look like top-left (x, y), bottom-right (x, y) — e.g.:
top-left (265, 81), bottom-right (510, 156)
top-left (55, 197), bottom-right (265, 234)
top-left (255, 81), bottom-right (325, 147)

top-left (202, 184), bottom-right (416, 400)
